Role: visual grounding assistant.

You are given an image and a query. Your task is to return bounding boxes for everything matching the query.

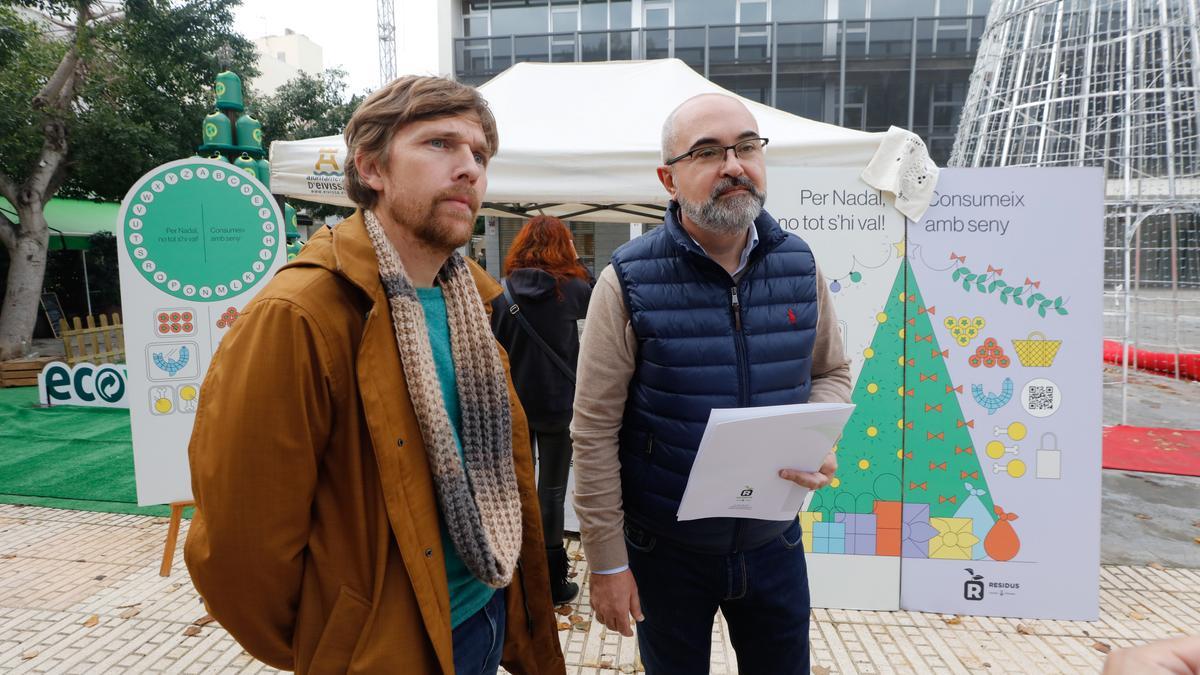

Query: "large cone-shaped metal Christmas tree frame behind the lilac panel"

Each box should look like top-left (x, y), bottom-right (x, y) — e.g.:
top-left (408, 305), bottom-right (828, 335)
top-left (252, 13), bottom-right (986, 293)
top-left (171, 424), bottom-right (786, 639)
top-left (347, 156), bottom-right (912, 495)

top-left (950, 0), bottom-right (1200, 422)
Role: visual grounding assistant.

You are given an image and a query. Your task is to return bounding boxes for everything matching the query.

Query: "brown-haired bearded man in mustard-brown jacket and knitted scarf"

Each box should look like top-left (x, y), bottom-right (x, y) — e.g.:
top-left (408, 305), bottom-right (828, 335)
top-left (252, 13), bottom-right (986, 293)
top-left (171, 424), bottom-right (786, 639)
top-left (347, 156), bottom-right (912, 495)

top-left (186, 77), bottom-right (565, 674)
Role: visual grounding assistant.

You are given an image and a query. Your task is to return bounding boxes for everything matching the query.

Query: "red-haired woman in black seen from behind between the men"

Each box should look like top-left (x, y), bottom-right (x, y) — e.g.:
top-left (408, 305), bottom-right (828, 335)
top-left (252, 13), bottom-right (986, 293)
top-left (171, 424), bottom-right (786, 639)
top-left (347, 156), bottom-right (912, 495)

top-left (492, 216), bottom-right (594, 604)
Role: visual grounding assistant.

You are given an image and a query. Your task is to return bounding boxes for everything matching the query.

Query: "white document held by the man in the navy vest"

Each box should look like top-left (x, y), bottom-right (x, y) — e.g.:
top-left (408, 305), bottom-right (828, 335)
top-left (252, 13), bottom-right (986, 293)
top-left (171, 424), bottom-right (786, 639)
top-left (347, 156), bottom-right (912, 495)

top-left (676, 404), bottom-right (854, 520)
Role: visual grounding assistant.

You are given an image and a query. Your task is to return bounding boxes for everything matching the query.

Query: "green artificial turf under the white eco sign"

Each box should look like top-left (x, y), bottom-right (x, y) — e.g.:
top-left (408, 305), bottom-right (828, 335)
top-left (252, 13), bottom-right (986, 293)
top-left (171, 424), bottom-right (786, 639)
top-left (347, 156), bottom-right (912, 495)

top-left (0, 387), bottom-right (180, 515)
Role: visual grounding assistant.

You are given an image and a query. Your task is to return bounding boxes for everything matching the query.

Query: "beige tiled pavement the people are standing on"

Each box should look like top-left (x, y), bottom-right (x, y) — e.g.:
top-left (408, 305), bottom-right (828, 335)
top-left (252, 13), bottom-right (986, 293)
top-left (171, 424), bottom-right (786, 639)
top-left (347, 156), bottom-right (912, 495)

top-left (0, 506), bottom-right (1200, 675)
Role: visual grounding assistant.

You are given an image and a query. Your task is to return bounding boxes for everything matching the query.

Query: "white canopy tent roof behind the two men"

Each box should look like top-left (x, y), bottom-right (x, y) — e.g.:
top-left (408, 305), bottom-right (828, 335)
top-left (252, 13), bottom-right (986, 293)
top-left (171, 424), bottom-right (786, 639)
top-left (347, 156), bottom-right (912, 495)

top-left (270, 59), bottom-right (936, 222)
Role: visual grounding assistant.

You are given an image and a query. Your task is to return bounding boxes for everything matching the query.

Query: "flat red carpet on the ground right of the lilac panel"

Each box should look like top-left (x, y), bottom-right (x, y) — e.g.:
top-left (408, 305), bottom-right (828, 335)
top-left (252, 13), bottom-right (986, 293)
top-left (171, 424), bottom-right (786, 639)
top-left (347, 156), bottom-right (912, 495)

top-left (1104, 425), bottom-right (1200, 476)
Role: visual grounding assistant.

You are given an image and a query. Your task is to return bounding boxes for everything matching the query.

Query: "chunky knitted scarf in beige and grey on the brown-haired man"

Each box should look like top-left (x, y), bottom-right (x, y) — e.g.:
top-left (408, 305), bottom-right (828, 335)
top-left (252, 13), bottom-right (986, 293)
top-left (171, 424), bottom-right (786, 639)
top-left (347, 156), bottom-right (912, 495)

top-left (364, 211), bottom-right (521, 589)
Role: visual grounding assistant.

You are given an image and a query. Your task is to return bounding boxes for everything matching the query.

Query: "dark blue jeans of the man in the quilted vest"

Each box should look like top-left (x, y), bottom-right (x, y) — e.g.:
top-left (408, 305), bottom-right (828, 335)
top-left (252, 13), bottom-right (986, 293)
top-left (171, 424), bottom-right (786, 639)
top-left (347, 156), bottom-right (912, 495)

top-left (625, 521), bottom-right (810, 675)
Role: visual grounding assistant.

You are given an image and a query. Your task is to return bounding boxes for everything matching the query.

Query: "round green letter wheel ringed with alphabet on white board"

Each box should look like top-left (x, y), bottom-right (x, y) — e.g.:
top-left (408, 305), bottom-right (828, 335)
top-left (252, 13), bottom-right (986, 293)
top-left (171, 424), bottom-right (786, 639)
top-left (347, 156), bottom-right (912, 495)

top-left (121, 159), bottom-right (283, 301)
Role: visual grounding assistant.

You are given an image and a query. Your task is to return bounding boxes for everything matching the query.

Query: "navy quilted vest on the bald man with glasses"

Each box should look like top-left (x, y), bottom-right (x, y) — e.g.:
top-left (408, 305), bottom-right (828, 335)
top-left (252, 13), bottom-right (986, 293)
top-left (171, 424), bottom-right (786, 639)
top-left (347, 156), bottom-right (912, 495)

top-left (612, 203), bottom-right (817, 550)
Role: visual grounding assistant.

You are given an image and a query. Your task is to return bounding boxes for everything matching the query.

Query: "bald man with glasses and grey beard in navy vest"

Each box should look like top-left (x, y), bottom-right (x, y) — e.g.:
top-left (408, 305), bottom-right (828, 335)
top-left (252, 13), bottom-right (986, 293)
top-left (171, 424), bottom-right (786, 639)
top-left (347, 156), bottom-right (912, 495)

top-left (571, 94), bottom-right (851, 675)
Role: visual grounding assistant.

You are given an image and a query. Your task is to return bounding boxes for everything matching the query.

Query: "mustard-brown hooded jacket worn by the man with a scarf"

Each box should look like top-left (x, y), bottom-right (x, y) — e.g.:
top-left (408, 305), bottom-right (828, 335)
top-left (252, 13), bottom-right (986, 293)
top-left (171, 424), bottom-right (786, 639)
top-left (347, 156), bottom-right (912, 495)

top-left (186, 213), bottom-right (565, 675)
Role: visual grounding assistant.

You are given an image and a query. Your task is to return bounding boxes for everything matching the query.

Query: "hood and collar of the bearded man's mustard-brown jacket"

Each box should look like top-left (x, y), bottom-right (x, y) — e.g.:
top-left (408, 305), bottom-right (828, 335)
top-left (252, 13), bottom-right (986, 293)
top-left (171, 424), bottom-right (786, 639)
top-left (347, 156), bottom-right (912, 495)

top-left (281, 209), bottom-right (502, 306)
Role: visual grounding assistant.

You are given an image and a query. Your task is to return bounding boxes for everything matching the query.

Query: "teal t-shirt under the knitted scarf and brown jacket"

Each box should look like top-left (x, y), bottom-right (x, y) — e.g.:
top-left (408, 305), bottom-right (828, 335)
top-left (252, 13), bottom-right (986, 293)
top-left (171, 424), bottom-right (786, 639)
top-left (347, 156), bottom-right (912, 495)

top-left (416, 287), bottom-right (496, 628)
